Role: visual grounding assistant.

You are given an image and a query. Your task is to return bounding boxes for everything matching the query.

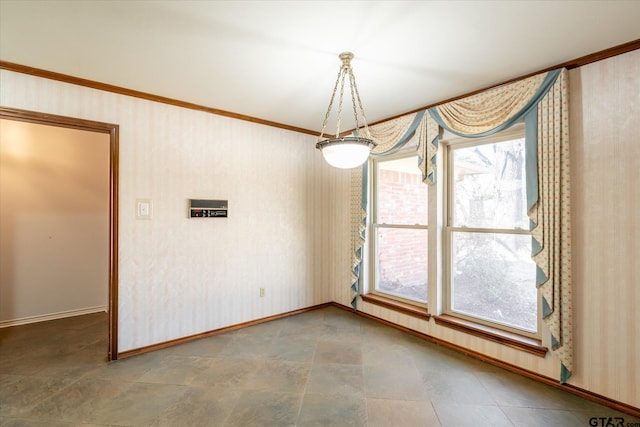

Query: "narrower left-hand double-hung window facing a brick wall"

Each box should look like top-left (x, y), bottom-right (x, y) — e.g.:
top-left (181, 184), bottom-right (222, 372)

top-left (371, 151), bottom-right (428, 305)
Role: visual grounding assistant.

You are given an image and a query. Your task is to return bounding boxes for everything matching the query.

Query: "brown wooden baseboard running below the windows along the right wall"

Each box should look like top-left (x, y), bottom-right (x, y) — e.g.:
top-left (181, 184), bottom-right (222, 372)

top-left (332, 302), bottom-right (640, 417)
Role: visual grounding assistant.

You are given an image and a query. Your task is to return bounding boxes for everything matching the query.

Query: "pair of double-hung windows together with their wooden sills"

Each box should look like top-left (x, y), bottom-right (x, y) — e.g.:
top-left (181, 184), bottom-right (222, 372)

top-left (363, 126), bottom-right (546, 342)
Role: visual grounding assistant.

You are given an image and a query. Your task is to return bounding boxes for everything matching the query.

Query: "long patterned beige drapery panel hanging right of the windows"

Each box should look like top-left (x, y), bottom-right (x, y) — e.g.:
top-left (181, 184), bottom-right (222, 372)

top-left (529, 70), bottom-right (573, 383)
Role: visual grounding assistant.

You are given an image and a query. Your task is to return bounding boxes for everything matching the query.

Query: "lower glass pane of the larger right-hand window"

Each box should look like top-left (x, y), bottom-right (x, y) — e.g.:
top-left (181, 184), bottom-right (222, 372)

top-left (451, 232), bottom-right (538, 332)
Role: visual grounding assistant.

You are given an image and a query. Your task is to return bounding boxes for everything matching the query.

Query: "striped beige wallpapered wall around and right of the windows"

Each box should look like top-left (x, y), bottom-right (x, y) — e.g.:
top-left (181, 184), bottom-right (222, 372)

top-left (335, 50), bottom-right (640, 407)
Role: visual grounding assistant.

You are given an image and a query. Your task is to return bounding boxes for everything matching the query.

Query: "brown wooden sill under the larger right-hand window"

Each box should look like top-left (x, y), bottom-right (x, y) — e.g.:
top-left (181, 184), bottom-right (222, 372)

top-left (433, 314), bottom-right (547, 357)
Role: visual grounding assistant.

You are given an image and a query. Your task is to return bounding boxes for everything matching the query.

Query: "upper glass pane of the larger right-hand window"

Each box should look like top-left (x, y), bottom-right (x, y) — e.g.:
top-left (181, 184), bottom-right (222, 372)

top-left (452, 139), bottom-right (529, 230)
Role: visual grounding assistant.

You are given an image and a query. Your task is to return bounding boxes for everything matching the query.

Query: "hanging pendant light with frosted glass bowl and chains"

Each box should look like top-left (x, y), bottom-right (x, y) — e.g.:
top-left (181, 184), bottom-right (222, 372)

top-left (316, 52), bottom-right (376, 169)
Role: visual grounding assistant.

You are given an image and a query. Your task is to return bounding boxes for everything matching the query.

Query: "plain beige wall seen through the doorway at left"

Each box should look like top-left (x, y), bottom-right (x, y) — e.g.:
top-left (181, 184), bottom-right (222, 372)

top-left (0, 120), bottom-right (109, 325)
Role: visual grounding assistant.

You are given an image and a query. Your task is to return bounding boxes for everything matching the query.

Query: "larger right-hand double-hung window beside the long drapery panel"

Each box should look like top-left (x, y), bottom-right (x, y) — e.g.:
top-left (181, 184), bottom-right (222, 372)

top-left (444, 131), bottom-right (539, 337)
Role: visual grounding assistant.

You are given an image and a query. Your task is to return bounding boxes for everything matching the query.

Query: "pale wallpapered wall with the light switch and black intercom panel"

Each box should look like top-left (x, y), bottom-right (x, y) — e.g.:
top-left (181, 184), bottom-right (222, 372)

top-left (0, 70), bottom-right (350, 352)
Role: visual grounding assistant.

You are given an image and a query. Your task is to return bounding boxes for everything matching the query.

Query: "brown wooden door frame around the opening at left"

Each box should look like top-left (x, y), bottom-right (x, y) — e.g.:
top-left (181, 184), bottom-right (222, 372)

top-left (0, 107), bottom-right (120, 360)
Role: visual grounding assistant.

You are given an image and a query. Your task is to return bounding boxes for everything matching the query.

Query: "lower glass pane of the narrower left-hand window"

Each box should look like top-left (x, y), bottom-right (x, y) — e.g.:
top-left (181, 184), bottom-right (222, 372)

top-left (376, 227), bottom-right (427, 302)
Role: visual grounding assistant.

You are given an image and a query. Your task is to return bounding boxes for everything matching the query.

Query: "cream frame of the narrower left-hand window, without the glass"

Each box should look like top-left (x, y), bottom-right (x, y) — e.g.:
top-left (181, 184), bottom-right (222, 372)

top-left (368, 145), bottom-right (431, 310)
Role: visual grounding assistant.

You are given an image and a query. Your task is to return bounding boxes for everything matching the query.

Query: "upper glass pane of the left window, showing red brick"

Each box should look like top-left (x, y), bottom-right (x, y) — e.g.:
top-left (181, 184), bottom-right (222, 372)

top-left (376, 156), bottom-right (428, 225)
